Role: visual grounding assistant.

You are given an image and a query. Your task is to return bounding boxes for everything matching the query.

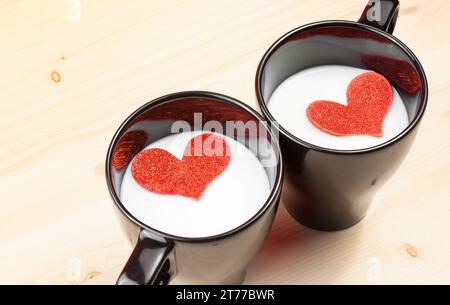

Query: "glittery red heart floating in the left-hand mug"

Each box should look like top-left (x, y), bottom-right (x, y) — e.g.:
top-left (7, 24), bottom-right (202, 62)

top-left (131, 133), bottom-right (231, 200)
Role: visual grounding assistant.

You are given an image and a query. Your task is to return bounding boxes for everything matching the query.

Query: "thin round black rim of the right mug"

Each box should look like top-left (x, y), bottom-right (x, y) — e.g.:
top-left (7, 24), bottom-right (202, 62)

top-left (255, 20), bottom-right (428, 155)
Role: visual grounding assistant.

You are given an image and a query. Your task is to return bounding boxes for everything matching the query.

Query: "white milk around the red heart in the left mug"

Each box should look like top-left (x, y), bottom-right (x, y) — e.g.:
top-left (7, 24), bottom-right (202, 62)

top-left (120, 131), bottom-right (270, 237)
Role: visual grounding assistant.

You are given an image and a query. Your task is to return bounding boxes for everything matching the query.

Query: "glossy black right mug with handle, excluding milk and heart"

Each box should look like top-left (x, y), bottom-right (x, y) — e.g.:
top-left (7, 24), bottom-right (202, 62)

top-left (255, 0), bottom-right (428, 231)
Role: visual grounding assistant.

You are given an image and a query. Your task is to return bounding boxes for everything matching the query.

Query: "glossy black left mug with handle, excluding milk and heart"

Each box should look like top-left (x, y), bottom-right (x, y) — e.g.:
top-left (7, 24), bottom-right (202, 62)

top-left (106, 91), bottom-right (283, 284)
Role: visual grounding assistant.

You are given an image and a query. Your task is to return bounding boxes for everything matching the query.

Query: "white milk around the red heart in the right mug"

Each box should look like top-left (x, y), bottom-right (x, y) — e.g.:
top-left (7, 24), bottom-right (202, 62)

top-left (268, 65), bottom-right (408, 150)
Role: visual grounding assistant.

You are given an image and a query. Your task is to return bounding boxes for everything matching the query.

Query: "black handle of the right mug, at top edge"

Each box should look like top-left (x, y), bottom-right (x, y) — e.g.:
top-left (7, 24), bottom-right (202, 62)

top-left (358, 0), bottom-right (400, 34)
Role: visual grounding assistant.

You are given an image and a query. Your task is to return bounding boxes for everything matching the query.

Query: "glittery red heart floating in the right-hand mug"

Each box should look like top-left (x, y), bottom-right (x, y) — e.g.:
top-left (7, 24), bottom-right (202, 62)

top-left (306, 72), bottom-right (392, 137)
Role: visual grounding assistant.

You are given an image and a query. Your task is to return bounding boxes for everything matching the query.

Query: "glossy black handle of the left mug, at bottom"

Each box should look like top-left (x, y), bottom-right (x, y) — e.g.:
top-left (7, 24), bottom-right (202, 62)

top-left (116, 229), bottom-right (177, 285)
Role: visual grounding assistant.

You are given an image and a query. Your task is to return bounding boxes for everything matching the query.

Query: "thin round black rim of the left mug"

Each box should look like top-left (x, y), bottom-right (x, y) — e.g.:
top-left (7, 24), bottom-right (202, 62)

top-left (105, 91), bottom-right (283, 243)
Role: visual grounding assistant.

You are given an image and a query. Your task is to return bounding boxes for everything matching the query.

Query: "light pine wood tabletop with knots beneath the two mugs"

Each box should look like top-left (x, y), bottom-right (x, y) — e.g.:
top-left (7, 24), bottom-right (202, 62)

top-left (0, 0), bottom-right (450, 284)
